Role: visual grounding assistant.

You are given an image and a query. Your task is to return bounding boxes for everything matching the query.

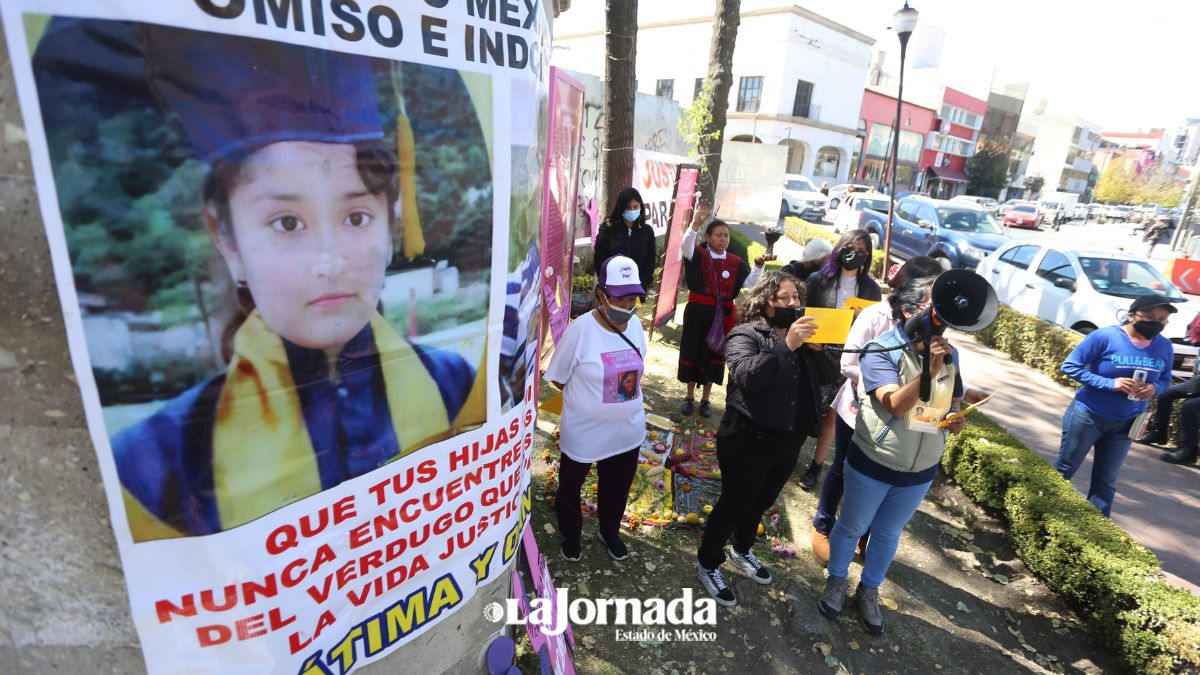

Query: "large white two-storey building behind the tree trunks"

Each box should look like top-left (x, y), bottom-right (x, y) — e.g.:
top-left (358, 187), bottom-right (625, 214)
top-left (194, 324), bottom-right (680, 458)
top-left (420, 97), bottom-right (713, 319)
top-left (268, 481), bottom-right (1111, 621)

top-left (552, 0), bottom-right (875, 184)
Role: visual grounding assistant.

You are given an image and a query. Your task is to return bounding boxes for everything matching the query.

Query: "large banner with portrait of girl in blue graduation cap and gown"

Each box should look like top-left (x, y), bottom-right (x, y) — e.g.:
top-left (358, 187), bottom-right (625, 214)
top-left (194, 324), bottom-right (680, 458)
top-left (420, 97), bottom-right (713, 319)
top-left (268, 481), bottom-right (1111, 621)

top-left (0, 0), bottom-right (551, 674)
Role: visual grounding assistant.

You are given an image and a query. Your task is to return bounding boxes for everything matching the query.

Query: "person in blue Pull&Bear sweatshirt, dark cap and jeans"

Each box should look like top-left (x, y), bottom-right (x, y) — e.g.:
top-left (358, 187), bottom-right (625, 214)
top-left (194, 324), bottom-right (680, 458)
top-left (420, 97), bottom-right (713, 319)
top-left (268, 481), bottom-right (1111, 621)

top-left (1054, 294), bottom-right (1178, 516)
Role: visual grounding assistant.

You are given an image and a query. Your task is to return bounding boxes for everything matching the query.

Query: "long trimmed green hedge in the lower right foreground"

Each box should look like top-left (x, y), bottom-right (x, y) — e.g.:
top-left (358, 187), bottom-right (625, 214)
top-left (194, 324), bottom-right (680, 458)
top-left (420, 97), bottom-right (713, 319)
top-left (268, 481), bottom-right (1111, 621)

top-left (942, 412), bottom-right (1200, 673)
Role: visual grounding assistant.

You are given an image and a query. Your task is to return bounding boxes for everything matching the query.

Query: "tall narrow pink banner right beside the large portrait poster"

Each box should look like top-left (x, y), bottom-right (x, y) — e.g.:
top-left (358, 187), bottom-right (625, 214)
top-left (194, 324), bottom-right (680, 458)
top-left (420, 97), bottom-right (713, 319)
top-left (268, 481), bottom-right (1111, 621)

top-left (541, 68), bottom-right (584, 342)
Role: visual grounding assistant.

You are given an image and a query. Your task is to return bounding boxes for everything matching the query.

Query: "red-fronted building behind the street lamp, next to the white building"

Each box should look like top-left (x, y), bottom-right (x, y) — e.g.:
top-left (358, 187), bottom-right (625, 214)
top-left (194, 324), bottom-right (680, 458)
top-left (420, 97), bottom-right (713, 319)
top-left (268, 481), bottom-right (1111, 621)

top-left (853, 89), bottom-right (937, 192)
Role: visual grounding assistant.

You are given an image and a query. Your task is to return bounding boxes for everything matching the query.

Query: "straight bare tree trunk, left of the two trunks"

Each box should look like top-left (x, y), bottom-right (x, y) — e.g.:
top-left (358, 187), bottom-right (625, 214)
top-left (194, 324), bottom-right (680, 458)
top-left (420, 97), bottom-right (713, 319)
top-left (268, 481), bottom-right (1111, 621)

top-left (596, 0), bottom-right (637, 212)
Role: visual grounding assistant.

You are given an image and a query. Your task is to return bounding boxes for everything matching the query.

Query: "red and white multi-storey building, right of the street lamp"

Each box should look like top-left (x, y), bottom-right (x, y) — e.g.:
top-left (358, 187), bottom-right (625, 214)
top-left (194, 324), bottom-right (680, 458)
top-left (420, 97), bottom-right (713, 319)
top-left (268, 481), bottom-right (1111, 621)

top-left (916, 86), bottom-right (988, 199)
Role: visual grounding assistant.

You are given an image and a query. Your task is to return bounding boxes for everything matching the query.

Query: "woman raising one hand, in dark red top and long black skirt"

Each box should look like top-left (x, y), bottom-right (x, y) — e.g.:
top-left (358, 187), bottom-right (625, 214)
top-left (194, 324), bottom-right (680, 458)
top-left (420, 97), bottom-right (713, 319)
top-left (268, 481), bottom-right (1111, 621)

top-left (678, 205), bottom-right (775, 417)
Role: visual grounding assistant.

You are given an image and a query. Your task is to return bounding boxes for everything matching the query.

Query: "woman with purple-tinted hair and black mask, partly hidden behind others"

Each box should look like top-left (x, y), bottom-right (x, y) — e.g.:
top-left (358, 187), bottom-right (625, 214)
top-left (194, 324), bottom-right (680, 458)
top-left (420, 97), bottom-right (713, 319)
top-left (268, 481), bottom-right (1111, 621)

top-left (800, 229), bottom-right (883, 490)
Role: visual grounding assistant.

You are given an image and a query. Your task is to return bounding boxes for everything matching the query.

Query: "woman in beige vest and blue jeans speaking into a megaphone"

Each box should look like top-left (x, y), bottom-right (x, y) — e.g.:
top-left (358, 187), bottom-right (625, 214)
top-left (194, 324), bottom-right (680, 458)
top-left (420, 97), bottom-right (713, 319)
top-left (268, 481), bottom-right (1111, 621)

top-left (817, 271), bottom-right (965, 634)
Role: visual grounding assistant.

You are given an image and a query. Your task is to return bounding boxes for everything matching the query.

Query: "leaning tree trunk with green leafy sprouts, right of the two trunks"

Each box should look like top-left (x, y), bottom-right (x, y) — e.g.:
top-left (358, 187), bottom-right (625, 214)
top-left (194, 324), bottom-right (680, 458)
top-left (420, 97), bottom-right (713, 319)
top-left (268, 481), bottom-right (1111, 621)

top-left (696, 0), bottom-right (742, 208)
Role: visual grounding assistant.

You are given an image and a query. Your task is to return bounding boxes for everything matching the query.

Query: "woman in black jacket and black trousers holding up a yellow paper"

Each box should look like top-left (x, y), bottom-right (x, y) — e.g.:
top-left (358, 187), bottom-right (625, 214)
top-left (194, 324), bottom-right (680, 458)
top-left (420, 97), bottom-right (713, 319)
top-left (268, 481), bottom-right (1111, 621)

top-left (696, 271), bottom-right (824, 607)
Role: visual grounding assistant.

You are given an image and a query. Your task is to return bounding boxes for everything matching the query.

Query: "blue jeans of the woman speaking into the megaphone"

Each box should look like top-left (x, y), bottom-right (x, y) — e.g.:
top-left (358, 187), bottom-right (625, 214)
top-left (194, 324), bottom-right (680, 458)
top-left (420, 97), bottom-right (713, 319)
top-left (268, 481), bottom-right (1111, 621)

top-left (829, 462), bottom-right (934, 589)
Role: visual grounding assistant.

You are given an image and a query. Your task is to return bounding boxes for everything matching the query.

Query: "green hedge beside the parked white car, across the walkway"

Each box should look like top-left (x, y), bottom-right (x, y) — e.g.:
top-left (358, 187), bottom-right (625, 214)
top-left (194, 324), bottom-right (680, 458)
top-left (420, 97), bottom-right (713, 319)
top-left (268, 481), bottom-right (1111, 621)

top-left (974, 306), bottom-right (1183, 446)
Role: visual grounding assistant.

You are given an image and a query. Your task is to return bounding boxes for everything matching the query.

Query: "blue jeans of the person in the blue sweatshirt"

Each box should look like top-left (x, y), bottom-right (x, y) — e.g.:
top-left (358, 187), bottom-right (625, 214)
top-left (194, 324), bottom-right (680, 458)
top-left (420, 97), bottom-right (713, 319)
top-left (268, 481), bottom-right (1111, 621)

top-left (1054, 401), bottom-right (1133, 518)
